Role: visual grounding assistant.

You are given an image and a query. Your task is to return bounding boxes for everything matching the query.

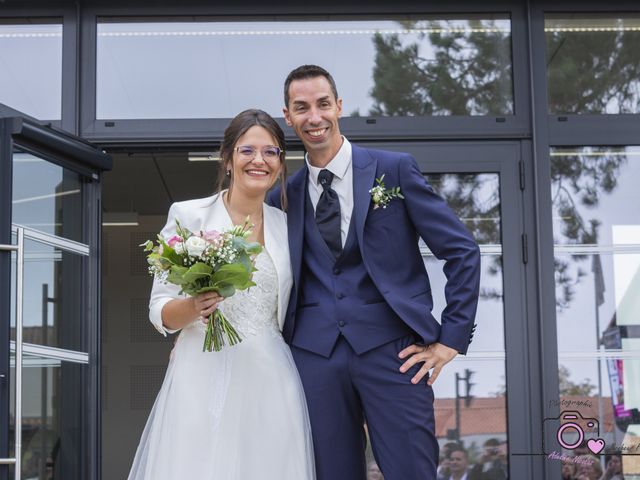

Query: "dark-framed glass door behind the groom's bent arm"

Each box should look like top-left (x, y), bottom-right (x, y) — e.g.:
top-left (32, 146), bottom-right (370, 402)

top-left (362, 142), bottom-right (528, 479)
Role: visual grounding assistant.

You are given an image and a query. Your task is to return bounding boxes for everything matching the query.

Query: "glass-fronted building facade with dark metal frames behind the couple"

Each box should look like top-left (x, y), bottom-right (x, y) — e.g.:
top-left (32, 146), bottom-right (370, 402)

top-left (0, 0), bottom-right (640, 480)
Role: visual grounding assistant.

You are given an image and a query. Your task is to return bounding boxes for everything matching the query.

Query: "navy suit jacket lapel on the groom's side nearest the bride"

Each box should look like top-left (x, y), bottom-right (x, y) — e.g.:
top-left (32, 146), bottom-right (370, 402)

top-left (287, 167), bottom-right (308, 289)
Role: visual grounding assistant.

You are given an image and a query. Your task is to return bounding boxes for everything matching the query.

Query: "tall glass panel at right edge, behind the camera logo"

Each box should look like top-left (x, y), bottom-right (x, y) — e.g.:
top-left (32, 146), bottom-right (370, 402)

top-left (551, 147), bottom-right (640, 474)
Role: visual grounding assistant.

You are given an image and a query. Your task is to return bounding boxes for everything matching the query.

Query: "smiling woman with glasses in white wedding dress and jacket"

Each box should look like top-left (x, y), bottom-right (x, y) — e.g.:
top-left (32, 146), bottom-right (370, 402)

top-left (129, 110), bottom-right (315, 480)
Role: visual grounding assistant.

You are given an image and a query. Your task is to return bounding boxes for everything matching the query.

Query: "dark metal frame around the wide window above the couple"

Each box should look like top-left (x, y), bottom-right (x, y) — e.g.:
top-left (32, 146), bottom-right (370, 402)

top-left (81, 1), bottom-right (530, 145)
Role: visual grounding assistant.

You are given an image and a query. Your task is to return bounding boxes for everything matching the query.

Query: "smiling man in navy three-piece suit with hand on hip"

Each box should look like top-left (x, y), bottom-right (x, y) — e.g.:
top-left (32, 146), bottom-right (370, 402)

top-left (269, 65), bottom-right (480, 480)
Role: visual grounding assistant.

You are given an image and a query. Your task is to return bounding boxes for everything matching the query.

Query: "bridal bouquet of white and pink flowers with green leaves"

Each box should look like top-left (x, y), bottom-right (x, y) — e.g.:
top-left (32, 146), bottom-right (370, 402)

top-left (140, 218), bottom-right (262, 352)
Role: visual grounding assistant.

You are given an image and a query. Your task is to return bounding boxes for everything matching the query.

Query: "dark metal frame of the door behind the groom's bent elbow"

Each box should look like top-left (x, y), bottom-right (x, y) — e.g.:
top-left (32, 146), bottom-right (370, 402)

top-left (364, 140), bottom-right (536, 479)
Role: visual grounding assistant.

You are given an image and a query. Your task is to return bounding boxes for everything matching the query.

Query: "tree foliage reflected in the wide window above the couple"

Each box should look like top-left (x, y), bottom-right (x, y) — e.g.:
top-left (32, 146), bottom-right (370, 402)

top-left (369, 20), bottom-right (513, 116)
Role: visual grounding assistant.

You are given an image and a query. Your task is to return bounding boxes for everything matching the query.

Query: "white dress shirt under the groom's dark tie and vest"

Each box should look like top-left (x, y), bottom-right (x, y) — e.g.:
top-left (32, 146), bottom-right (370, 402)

top-left (305, 137), bottom-right (353, 247)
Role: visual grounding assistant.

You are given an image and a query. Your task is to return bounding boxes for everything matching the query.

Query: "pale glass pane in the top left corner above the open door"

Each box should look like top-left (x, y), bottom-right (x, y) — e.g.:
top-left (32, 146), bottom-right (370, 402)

top-left (0, 19), bottom-right (62, 120)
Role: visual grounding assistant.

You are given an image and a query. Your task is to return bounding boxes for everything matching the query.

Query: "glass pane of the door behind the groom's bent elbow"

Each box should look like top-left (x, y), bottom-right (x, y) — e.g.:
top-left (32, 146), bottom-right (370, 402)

top-left (425, 173), bottom-right (508, 478)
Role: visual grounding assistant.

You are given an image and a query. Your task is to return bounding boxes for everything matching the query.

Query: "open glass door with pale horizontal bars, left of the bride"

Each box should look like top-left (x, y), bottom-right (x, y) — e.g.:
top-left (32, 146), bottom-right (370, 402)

top-left (0, 110), bottom-right (109, 480)
